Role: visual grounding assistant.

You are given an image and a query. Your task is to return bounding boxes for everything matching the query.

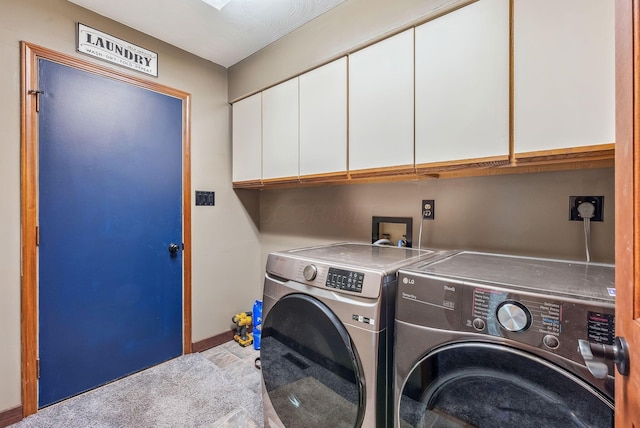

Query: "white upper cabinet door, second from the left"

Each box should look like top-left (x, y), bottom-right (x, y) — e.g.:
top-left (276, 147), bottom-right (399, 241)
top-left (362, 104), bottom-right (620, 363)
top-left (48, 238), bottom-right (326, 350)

top-left (262, 77), bottom-right (298, 179)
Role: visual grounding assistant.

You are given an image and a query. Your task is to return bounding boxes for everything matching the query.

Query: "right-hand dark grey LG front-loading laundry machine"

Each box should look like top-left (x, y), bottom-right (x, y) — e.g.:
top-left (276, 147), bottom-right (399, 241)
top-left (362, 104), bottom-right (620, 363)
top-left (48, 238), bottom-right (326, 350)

top-left (394, 252), bottom-right (615, 428)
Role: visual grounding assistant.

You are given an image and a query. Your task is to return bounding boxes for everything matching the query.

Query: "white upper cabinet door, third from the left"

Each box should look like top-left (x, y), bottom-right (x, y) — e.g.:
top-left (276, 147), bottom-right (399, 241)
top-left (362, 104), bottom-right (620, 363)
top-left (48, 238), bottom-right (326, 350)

top-left (300, 57), bottom-right (347, 176)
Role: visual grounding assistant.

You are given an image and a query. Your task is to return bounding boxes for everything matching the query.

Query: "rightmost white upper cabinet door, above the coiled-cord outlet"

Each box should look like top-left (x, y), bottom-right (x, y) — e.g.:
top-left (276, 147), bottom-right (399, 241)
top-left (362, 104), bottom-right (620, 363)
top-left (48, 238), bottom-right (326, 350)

top-left (513, 0), bottom-right (615, 153)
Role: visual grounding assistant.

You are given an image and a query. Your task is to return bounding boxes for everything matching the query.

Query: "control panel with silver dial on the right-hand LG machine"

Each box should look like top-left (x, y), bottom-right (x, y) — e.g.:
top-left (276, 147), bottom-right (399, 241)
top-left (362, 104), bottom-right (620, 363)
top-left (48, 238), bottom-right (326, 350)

top-left (396, 271), bottom-right (615, 364)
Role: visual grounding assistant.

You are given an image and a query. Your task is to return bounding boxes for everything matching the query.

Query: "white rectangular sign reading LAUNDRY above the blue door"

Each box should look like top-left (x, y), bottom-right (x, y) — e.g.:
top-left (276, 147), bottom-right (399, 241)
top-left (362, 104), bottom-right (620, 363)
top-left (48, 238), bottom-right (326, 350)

top-left (77, 23), bottom-right (158, 77)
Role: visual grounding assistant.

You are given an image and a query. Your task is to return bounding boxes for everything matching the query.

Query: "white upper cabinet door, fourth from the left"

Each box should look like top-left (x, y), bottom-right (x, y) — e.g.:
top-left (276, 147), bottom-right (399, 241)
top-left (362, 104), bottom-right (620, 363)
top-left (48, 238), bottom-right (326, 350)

top-left (349, 29), bottom-right (414, 171)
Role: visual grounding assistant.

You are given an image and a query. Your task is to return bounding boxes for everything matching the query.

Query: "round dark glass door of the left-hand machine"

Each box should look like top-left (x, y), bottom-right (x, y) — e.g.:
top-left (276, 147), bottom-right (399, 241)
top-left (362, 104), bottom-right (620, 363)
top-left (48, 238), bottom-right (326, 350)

top-left (260, 294), bottom-right (365, 428)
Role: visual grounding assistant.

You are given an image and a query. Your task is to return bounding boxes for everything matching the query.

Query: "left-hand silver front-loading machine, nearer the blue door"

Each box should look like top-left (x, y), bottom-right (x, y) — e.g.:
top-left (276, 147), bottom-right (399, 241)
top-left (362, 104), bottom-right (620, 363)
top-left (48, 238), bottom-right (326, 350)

top-left (260, 243), bottom-right (448, 428)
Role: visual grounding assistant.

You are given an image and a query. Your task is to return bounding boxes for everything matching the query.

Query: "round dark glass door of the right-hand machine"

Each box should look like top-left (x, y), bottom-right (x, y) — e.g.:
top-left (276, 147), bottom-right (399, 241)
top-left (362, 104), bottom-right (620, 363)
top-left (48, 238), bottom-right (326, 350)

top-left (398, 343), bottom-right (614, 428)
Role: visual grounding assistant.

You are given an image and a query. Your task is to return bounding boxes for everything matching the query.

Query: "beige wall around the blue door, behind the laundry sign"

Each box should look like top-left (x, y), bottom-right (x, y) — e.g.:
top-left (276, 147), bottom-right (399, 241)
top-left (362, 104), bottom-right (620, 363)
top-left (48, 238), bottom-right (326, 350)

top-left (0, 0), bottom-right (262, 412)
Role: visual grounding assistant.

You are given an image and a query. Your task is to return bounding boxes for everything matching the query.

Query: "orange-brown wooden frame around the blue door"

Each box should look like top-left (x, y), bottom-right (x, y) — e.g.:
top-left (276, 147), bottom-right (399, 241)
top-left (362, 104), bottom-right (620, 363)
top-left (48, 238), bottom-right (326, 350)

top-left (20, 41), bottom-right (192, 417)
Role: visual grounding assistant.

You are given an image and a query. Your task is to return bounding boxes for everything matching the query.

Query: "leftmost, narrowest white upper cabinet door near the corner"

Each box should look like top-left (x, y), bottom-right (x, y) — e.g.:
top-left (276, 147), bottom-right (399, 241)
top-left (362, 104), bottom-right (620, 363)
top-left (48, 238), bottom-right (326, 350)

top-left (231, 93), bottom-right (262, 182)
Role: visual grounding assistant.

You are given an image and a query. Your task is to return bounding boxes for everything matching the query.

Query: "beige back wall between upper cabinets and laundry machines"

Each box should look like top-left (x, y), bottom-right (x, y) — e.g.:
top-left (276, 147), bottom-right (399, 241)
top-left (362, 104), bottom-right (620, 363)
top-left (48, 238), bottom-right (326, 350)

top-left (260, 168), bottom-right (614, 280)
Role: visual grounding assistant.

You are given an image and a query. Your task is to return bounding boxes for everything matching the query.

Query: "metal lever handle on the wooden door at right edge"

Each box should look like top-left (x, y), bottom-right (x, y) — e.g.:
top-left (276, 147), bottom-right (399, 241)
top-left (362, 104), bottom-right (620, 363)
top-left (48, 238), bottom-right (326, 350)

top-left (578, 336), bottom-right (629, 379)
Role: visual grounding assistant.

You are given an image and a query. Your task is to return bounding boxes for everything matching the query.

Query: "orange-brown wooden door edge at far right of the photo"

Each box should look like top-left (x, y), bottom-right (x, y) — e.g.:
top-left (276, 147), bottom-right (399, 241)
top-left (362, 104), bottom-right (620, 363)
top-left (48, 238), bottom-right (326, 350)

top-left (615, 0), bottom-right (640, 427)
